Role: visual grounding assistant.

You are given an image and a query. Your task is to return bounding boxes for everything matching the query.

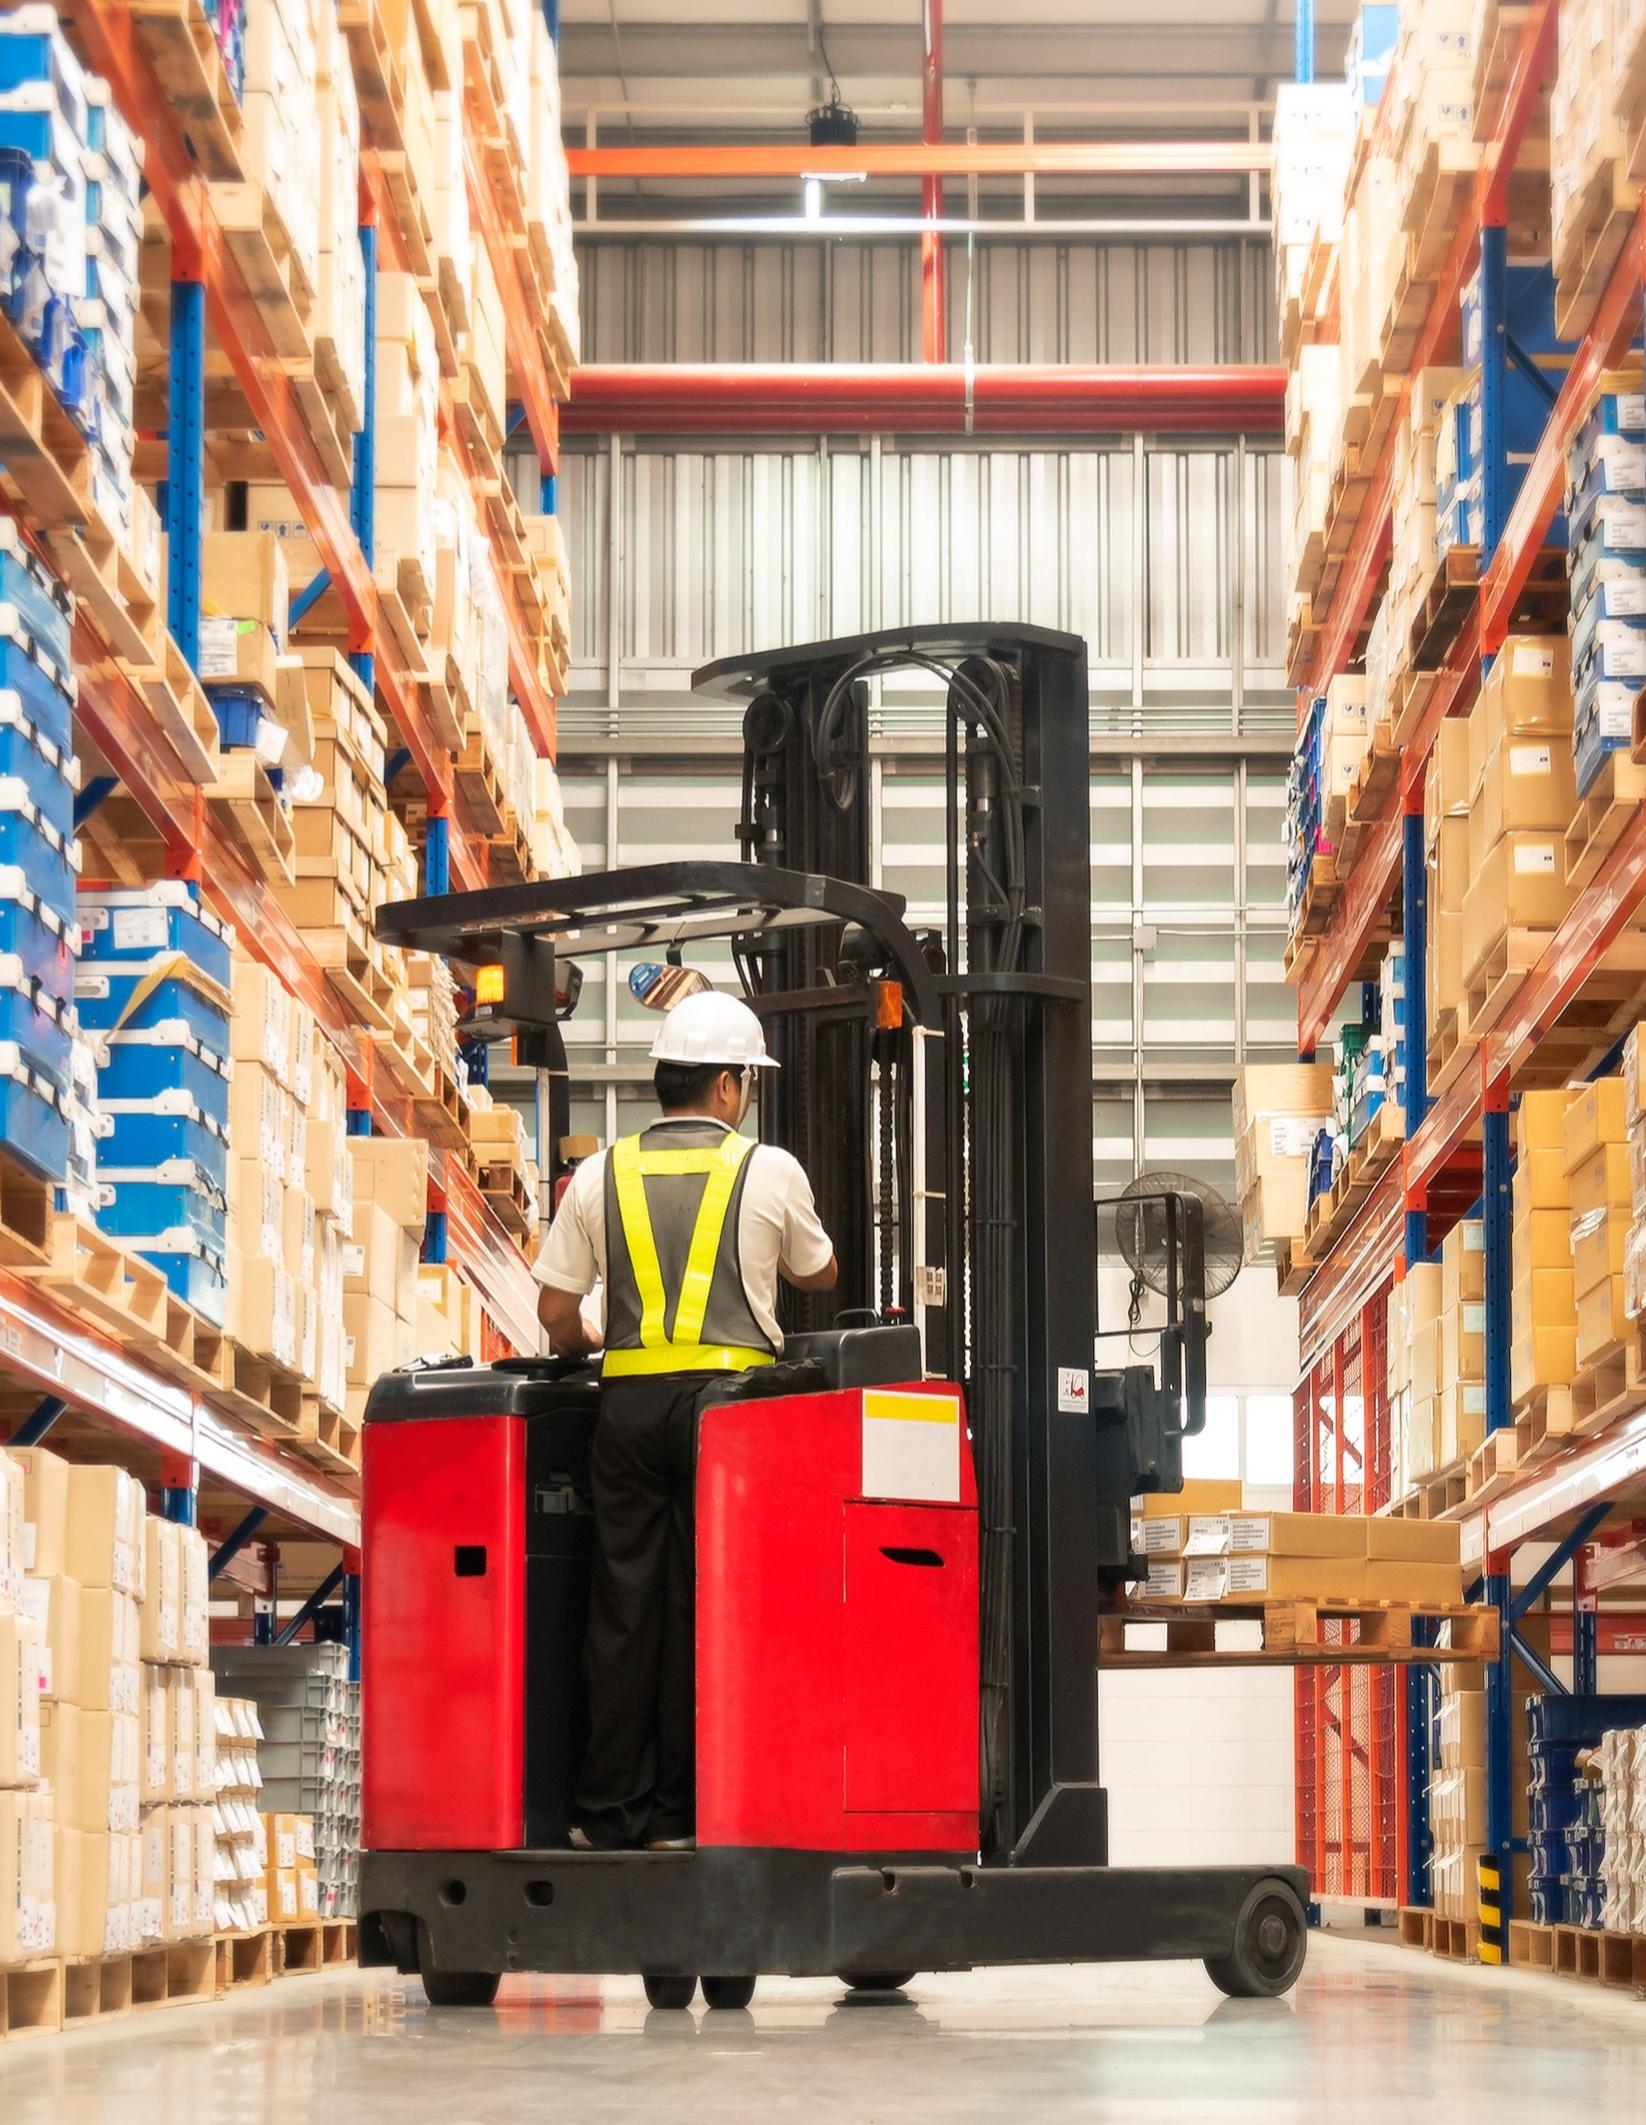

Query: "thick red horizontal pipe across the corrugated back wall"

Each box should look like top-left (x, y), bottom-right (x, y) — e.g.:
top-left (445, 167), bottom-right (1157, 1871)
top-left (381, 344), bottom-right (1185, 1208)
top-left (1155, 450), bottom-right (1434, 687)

top-left (561, 363), bottom-right (1285, 436)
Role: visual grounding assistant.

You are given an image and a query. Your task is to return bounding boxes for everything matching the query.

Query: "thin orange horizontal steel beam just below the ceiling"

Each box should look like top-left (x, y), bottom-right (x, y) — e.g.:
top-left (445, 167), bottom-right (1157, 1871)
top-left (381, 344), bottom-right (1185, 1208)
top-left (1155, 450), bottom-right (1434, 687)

top-left (567, 140), bottom-right (1272, 179)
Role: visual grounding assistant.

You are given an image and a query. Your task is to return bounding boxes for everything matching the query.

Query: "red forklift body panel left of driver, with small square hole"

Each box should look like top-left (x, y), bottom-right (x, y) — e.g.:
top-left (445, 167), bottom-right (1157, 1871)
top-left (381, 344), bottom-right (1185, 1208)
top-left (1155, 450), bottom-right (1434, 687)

top-left (361, 1417), bottom-right (525, 1851)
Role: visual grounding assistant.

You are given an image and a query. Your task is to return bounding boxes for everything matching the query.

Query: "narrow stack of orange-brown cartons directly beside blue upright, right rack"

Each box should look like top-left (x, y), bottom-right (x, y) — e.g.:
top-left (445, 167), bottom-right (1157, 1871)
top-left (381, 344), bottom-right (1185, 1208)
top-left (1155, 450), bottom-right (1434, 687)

top-left (1508, 1090), bottom-right (1578, 1409)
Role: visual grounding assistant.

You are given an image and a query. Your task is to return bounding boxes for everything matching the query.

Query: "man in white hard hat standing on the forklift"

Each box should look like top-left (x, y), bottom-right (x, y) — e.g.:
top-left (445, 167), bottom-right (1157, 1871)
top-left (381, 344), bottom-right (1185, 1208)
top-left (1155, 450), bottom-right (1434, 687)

top-left (537, 990), bottom-right (839, 1851)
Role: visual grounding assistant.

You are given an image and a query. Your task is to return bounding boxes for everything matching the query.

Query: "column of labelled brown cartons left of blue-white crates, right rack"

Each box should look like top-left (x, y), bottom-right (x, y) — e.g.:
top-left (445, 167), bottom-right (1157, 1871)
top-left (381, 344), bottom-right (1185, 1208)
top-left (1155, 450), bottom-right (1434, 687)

top-left (1463, 635), bottom-right (1576, 988)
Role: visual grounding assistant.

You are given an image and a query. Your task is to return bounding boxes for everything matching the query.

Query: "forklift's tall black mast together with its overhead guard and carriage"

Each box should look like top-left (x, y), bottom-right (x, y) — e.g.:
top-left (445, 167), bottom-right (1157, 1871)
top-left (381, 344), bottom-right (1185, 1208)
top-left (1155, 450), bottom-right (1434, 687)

top-left (378, 625), bottom-right (1204, 1866)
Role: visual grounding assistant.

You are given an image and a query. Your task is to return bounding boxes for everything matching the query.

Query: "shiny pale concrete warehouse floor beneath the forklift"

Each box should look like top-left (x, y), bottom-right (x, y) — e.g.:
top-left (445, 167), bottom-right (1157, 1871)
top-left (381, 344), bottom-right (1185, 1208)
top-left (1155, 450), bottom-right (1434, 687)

top-left (0, 1936), bottom-right (1646, 2125)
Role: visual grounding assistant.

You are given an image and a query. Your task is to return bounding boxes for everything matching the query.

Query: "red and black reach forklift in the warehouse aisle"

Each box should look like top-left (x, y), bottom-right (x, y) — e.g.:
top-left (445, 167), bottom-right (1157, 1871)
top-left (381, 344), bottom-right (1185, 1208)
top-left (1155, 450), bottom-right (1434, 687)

top-left (359, 625), bottom-right (1308, 2006)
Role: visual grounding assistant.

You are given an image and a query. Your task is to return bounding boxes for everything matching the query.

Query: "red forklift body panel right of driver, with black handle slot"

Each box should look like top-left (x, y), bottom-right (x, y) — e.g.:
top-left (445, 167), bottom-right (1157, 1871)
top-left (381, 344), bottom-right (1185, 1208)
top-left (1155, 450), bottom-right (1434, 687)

top-left (697, 1388), bottom-right (977, 1853)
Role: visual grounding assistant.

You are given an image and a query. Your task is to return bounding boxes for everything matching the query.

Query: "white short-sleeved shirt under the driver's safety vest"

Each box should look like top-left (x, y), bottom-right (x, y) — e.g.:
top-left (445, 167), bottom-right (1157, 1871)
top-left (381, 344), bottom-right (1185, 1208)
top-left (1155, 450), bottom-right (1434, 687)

top-left (537, 1114), bottom-right (835, 1349)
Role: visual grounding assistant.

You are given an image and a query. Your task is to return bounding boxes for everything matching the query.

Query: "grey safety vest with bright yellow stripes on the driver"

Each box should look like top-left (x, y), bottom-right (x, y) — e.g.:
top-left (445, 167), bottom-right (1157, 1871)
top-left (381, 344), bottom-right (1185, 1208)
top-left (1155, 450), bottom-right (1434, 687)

top-left (603, 1122), bottom-right (775, 1379)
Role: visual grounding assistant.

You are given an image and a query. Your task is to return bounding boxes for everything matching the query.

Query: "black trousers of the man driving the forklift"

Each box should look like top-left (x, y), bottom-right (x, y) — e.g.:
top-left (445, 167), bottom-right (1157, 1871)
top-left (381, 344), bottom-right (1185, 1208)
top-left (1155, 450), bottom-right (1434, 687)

top-left (578, 1373), bottom-right (703, 1845)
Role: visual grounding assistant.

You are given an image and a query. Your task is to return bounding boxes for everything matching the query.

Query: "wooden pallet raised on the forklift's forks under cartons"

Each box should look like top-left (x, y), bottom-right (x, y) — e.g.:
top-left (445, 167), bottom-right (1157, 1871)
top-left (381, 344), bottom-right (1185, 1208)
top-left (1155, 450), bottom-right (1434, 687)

top-left (1098, 1598), bottom-right (1497, 1668)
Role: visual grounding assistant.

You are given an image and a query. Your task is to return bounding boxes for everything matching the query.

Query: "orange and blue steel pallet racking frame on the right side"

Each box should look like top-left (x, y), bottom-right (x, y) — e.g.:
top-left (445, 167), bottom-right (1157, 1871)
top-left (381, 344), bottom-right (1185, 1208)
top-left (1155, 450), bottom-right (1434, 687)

top-left (1293, 0), bottom-right (1646, 1953)
